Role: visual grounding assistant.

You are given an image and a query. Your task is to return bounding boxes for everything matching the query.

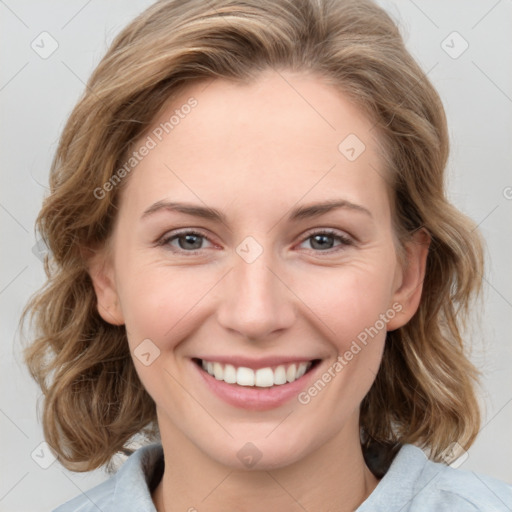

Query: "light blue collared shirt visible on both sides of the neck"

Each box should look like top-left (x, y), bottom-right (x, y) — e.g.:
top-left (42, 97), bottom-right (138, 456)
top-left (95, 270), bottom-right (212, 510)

top-left (54, 443), bottom-right (512, 512)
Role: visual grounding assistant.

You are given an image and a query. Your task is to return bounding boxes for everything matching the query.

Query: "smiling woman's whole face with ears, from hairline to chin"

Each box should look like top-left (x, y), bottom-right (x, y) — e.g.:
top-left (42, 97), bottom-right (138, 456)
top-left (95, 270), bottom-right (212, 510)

top-left (91, 71), bottom-right (426, 468)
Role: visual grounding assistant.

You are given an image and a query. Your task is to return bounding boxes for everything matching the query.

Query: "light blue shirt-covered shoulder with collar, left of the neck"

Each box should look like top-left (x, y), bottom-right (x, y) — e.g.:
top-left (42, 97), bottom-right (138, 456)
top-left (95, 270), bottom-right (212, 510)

top-left (53, 443), bottom-right (163, 512)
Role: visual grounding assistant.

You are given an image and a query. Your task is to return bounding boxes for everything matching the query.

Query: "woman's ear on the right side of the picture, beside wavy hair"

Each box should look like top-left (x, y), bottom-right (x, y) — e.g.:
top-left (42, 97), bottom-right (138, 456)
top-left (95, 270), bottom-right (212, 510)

top-left (387, 228), bottom-right (431, 331)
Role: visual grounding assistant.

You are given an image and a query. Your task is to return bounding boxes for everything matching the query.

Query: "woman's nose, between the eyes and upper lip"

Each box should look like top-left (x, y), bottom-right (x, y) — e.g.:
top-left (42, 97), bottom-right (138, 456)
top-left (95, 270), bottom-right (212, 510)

top-left (217, 247), bottom-right (296, 341)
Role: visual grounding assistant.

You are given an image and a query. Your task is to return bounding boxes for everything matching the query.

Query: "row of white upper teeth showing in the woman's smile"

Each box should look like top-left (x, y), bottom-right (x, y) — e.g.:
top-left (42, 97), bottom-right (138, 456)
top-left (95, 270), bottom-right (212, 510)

top-left (201, 360), bottom-right (312, 388)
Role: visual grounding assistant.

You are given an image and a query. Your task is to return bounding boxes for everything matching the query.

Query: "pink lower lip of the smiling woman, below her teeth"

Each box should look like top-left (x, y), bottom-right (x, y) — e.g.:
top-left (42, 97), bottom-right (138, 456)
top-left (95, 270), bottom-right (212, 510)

top-left (191, 360), bottom-right (320, 411)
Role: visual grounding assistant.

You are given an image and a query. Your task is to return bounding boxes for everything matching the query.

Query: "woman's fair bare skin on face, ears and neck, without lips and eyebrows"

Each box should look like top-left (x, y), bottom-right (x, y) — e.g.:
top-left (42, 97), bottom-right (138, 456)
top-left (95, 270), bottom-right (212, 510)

top-left (90, 71), bottom-right (428, 512)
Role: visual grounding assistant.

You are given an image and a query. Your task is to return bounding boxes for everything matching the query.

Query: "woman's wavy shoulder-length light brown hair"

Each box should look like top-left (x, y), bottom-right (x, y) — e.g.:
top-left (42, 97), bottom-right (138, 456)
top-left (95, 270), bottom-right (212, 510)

top-left (22, 0), bottom-right (483, 475)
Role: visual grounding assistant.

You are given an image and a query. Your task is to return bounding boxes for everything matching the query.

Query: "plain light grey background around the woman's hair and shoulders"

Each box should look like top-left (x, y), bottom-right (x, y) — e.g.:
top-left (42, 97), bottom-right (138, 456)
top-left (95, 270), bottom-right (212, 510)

top-left (0, 0), bottom-right (512, 512)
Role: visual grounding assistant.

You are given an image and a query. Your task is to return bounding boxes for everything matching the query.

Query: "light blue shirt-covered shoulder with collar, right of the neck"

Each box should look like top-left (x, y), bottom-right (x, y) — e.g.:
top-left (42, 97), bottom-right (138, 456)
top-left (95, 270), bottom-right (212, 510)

top-left (357, 444), bottom-right (512, 512)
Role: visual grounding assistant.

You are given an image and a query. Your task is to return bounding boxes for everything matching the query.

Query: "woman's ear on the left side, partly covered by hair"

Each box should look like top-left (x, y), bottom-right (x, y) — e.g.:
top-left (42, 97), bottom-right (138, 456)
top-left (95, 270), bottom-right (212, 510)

top-left (82, 248), bottom-right (124, 325)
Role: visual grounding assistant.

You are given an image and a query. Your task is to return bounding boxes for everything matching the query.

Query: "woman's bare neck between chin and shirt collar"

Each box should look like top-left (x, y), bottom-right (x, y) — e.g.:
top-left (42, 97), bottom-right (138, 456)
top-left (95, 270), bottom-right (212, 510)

top-left (153, 417), bottom-right (378, 512)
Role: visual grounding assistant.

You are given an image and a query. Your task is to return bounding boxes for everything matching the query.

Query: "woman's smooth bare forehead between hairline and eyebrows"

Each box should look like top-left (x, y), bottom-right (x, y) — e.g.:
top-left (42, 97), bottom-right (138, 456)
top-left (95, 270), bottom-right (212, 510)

top-left (123, 71), bottom-right (388, 220)
